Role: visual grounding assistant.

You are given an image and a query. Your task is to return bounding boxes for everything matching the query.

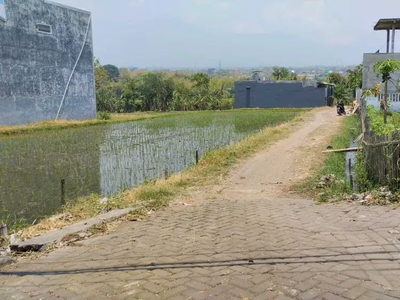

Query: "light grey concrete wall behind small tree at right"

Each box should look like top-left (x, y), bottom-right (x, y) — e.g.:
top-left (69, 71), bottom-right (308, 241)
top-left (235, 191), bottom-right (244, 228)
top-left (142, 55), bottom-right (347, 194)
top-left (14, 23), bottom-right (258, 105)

top-left (363, 53), bottom-right (400, 93)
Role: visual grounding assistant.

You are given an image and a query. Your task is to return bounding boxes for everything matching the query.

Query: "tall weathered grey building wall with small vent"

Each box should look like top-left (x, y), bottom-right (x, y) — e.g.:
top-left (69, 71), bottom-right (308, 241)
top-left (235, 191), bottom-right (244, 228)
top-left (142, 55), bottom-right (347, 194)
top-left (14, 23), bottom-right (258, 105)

top-left (0, 0), bottom-right (96, 125)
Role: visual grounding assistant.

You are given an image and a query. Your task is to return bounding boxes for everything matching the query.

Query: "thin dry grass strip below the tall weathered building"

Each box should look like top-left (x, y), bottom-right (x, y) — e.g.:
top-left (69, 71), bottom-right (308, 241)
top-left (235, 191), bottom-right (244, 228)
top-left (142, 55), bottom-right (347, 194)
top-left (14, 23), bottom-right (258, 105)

top-left (0, 112), bottom-right (177, 136)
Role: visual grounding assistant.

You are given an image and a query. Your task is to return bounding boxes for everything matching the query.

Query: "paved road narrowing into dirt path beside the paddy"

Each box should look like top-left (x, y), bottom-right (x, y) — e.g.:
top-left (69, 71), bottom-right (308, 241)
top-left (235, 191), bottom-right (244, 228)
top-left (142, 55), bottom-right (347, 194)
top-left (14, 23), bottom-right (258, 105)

top-left (0, 109), bottom-right (400, 300)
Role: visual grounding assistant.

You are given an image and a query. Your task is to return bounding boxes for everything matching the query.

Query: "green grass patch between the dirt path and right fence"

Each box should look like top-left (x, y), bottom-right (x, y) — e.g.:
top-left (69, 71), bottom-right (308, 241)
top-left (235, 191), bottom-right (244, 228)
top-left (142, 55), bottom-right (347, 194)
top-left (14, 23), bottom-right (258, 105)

top-left (295, 115), bottom-right (361, 203)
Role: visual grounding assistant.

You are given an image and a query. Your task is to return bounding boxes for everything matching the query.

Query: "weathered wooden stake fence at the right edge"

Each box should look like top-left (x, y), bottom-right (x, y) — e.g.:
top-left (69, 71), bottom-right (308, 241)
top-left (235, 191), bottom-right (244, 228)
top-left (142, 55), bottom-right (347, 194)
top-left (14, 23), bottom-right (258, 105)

top-left (360, 100), bottom-right (400, 190)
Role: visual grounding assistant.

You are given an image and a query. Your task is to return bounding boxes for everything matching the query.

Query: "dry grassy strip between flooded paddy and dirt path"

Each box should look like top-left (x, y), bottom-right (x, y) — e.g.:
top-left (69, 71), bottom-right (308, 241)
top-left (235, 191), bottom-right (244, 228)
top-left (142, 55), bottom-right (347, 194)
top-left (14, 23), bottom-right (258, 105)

top-left (18, 110), bottom-right (310, 239)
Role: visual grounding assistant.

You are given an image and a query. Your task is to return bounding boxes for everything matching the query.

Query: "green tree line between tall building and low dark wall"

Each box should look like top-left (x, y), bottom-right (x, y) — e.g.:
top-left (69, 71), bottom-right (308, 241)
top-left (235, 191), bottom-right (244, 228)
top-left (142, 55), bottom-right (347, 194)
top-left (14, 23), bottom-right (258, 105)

top-left (95, 60), bottom-right (243, 113)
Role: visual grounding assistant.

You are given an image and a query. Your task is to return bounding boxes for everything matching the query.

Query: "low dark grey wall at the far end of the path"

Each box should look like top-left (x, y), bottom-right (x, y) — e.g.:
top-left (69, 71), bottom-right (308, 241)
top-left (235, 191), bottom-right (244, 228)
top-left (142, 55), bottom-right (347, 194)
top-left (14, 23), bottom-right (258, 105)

top-left (235, 81), bottom-right (327, 108)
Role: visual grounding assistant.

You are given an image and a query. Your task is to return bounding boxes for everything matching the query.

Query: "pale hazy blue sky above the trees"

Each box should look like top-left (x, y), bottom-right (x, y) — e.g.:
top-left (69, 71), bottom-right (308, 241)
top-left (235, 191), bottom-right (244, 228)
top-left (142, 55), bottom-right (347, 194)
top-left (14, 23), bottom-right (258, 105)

top-left (54, 0), bottom-right (400, 68)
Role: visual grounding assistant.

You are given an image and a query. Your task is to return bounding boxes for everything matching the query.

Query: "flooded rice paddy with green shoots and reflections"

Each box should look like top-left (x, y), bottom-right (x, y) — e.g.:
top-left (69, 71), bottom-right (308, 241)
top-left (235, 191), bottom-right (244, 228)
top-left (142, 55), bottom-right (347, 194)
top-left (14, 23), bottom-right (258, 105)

top-left (0, 109), bottom-right (305, 224)
